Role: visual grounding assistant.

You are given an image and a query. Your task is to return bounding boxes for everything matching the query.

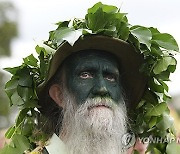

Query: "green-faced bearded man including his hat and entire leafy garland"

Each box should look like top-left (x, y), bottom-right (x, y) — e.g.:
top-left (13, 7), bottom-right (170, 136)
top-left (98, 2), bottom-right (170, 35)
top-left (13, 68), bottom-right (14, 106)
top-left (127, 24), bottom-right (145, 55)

top-left (3, 2), bottom-right (179, 154)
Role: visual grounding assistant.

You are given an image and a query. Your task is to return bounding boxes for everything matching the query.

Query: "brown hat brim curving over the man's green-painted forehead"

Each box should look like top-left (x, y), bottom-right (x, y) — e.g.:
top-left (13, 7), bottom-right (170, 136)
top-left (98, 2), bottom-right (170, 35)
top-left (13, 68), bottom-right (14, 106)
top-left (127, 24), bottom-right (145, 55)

top-left (44, 35), bottom-right (147, 107)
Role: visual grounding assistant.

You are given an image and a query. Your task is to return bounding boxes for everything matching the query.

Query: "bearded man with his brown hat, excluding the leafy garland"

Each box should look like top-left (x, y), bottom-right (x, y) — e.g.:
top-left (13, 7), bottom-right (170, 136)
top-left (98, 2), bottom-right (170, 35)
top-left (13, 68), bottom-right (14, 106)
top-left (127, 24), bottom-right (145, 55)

top-left (40, 36), bottom-right (145, 154)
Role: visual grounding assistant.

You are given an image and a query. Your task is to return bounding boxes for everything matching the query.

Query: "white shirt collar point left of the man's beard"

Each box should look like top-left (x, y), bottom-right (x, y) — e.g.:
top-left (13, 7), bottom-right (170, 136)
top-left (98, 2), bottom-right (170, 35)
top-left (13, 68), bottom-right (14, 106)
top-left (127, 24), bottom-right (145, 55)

top-left (45, 134), bottom-right (67, 154)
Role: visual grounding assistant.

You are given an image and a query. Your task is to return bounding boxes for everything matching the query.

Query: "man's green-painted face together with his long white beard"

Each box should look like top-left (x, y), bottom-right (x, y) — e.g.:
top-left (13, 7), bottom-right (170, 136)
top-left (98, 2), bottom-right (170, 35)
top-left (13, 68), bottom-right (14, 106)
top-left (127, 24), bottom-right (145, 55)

top-left (60, 50), bottom-right (127, 154)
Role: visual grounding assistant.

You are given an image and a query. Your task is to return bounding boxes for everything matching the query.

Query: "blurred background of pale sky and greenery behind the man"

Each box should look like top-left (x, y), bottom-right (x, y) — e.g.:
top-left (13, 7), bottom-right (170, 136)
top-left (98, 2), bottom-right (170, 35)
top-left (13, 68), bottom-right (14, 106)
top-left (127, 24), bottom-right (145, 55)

top-left (0, 0), bottom-right (180, 147)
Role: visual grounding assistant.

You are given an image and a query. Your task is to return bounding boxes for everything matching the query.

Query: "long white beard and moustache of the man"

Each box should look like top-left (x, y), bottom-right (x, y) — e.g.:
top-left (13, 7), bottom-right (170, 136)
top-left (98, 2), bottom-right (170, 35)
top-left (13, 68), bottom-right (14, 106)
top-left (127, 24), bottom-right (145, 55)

top-left (60, 91), bottom-right (127, 154)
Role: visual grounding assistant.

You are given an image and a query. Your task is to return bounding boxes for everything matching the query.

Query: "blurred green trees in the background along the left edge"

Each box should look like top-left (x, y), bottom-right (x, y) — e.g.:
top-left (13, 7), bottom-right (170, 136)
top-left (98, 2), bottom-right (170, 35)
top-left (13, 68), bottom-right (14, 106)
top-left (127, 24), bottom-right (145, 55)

top-left (0, 1), bottom-right (17, 128)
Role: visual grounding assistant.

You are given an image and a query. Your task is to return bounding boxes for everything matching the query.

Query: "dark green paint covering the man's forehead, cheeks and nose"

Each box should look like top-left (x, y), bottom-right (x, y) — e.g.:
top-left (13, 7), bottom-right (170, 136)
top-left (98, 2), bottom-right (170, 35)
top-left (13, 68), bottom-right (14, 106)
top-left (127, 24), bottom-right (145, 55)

top-left (65, 50), bottom-right (122, 105)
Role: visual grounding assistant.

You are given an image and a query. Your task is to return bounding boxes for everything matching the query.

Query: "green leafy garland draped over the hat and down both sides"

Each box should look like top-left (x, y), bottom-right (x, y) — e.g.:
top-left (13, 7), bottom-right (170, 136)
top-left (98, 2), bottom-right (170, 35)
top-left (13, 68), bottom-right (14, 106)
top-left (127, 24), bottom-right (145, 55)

top-left (0, 2), bottom-right (179, 153)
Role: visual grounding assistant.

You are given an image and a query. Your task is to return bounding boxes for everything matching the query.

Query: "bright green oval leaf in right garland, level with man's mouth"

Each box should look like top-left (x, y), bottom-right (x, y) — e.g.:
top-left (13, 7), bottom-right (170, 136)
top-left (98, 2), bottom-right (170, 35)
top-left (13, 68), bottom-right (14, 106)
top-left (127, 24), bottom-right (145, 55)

top-left (146, 103), bottom-right (167, 116)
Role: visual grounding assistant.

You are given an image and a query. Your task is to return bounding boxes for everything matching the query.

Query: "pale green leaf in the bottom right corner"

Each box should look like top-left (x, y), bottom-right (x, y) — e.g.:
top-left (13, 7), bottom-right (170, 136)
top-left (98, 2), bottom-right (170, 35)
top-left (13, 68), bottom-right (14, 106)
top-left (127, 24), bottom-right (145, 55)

top-left (166, 142), bottom-right (180, 154)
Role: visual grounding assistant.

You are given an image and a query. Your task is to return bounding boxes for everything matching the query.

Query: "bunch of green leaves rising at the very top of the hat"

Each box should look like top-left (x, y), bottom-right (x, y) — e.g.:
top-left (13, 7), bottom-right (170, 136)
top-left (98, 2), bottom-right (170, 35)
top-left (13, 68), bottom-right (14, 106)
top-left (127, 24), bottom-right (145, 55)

top-left (85, 3), bottom-right (121, 33)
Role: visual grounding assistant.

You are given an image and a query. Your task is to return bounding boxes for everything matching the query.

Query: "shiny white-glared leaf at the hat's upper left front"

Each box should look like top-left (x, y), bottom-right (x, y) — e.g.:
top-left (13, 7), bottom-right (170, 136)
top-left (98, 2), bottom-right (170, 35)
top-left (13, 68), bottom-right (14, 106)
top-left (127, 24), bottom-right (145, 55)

top-left (54, 27), bottom-right (82, 46)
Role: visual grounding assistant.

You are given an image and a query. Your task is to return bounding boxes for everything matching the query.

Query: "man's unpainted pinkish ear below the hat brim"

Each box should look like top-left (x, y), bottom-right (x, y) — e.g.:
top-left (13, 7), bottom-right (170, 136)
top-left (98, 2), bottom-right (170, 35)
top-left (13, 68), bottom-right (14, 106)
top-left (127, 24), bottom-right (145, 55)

top-left (49, 84), bottom-right (64, 108)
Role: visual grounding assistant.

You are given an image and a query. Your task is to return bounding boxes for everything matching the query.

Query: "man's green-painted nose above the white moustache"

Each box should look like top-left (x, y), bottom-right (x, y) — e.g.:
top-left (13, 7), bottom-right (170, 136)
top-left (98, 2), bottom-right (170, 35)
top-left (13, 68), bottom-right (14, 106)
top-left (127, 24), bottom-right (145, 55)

top-left (92, 78), bottom-right (109, 96)
